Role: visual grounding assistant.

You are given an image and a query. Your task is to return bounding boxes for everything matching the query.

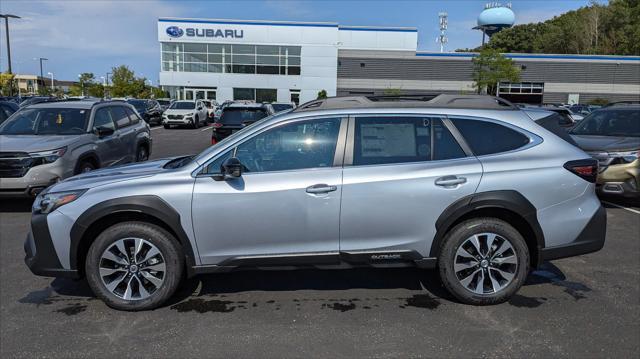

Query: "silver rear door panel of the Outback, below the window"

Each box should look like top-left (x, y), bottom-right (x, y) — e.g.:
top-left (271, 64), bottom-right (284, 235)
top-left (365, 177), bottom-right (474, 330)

top-left (340, 157), bottom-right (482, 257)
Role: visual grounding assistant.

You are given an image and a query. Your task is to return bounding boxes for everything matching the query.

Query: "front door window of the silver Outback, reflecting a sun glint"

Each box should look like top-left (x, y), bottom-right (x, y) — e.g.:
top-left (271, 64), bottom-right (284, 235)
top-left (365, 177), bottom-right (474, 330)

top-left (236, 118), bottom-right (340, 172)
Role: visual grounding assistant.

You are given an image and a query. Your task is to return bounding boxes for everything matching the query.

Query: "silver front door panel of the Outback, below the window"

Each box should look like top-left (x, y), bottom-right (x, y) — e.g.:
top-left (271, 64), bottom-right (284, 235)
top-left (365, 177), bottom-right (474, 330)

top-left (193, 168), bottom-right (342, 264)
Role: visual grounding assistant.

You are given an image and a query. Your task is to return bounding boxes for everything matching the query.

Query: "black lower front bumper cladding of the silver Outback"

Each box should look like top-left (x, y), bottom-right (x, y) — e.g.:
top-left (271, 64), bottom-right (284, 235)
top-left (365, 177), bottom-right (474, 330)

top-left (24, 214), bottom-right (79, 278)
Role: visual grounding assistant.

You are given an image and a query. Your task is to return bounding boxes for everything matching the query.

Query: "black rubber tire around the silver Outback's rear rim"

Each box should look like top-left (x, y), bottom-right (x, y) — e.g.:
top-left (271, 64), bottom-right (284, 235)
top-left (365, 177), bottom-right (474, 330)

top-left (438, 218), bottom-right (529, 305)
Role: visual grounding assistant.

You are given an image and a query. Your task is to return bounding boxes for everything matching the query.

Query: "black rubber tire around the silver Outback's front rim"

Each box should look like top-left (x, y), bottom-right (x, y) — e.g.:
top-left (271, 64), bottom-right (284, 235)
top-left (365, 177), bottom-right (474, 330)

top-left (85, 222), bottom-right (184, 311)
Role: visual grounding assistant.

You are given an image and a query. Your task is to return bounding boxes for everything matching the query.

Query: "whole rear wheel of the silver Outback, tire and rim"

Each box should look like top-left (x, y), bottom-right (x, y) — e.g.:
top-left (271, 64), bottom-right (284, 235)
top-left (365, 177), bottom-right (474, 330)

top-left (438, 218), bottom-right (529, 305)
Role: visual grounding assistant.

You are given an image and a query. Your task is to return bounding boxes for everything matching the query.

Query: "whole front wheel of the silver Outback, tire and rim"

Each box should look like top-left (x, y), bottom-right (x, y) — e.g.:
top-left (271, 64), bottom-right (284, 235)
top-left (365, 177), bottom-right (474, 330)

top-left (85, 222), bottom-right (184, 311)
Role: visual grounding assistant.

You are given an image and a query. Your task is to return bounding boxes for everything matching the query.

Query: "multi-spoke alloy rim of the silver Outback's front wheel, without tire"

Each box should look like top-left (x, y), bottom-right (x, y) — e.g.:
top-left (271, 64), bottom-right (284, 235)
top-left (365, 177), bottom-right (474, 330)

top-left (99, 238), bottom-right (167, 300)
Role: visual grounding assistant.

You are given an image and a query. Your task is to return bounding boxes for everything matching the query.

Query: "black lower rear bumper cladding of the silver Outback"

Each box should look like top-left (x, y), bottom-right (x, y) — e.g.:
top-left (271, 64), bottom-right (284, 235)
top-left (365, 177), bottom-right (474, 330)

top-left (539, 206), bottom-right (607, 263)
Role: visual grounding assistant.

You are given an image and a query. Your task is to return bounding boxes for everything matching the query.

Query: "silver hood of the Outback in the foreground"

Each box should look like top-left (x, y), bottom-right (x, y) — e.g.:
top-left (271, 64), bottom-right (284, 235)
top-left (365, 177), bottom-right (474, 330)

top-left (47, 157), bottom-right (177, 192)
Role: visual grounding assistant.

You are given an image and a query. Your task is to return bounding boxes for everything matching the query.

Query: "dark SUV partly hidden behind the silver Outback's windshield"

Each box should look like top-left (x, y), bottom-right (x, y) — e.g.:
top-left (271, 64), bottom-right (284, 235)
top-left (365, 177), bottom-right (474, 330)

top-left (211, 102), bottom-right (275, 144)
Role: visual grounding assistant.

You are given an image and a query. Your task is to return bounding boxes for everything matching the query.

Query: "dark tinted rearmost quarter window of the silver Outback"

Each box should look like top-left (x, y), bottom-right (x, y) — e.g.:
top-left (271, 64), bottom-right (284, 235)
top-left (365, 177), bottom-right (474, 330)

top-left (451, 119), bottom-right (529, 156)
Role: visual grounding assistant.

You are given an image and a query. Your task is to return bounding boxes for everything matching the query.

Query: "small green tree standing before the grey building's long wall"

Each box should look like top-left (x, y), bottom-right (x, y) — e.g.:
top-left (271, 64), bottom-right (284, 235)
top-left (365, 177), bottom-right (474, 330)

top-left (471, 47), bottom-right (520, 95)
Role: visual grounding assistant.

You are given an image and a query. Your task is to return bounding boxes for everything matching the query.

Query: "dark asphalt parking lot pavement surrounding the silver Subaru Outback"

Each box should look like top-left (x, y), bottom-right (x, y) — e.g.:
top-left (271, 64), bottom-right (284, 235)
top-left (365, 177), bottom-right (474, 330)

top-left (0, 128), bottom-right (640, 358)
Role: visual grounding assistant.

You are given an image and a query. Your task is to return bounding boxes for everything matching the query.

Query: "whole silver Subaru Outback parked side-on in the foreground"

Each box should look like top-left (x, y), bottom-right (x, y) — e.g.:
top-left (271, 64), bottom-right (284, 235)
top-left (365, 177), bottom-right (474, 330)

top-left (25, 95), bottom-right (606, 310)
